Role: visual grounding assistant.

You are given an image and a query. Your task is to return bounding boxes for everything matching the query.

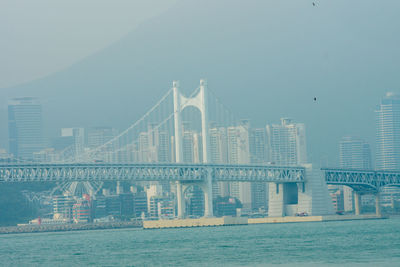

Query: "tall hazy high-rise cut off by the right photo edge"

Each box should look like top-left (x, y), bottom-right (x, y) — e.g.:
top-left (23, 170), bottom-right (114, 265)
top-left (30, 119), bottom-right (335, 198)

top-left (376, 92), bottom-right (400, 206)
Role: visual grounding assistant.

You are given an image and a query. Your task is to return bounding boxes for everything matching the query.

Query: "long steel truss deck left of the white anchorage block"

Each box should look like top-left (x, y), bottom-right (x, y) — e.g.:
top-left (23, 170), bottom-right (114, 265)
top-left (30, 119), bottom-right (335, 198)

top-left (0, 163), bottom-right (305, 183)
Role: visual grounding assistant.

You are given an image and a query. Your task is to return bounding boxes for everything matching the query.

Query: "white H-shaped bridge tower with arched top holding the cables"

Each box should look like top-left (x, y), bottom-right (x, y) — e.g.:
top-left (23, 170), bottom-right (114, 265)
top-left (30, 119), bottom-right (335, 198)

top-left (172, 79), bottom-right (213, 218)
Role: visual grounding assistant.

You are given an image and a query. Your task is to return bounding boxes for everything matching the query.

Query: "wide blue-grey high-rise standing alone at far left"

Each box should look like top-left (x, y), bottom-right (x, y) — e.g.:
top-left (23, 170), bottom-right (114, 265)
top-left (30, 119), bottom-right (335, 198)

top-left (8, 97), bottom-right (44, 160)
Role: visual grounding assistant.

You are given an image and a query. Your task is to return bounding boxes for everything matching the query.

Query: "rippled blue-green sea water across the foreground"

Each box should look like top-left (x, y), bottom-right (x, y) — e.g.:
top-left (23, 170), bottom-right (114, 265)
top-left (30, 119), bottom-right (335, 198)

top-left (0, 218), bottom-right (400, 266)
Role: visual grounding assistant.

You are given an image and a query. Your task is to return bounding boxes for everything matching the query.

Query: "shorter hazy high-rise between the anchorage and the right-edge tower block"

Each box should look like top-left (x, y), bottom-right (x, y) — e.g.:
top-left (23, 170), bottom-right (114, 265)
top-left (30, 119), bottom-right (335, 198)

top-left (339, 136), bottom-right (371, 211)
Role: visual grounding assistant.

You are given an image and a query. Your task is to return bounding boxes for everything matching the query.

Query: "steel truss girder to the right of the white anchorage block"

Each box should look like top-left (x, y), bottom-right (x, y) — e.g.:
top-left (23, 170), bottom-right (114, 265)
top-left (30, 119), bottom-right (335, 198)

top-left (322, 169), bottom-right (400, 194)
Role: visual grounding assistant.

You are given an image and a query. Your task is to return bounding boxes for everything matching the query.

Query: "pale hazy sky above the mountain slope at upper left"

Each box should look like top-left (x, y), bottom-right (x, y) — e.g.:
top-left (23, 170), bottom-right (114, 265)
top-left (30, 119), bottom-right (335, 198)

top-left (0, 0), bottom-right (176, 88)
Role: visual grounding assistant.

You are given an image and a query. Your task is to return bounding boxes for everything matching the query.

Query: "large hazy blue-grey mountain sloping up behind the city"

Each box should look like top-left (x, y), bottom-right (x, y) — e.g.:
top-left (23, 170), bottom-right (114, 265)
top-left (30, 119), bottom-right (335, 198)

top-left (0, 0), bottom-right (400, 165)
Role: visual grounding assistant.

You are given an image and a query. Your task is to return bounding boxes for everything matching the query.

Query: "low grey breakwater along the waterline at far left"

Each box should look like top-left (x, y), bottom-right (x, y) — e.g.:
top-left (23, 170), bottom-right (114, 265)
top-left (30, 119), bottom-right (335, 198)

top-left (0, 222), bottom-right (142, 234)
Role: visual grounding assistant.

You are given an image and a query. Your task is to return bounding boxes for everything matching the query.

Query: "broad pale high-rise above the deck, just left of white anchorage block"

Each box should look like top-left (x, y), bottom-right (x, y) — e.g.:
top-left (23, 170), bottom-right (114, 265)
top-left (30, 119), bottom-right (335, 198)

top-left (267, 118), bottom-right (307, 165)
